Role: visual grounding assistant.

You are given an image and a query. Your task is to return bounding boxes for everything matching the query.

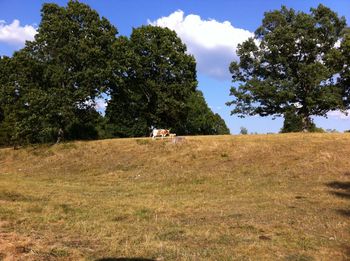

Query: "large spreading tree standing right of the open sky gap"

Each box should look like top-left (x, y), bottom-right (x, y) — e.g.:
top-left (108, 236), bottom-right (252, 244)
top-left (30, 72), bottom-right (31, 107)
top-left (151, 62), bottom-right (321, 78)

top-left (227, 5), bottom-right (346, 130)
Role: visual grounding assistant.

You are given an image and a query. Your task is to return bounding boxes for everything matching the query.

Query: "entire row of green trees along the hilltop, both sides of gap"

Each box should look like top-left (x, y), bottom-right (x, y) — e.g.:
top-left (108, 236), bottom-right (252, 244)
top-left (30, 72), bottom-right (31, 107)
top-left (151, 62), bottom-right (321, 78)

top-left (0, 1), bottom-right (350, 145)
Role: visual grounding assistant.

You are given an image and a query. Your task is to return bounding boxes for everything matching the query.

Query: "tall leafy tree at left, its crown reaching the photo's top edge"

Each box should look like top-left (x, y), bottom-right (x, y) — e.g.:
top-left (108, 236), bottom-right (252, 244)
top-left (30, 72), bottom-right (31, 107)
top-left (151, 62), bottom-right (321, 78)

top-left (1, 1), bottom-right (117, 142)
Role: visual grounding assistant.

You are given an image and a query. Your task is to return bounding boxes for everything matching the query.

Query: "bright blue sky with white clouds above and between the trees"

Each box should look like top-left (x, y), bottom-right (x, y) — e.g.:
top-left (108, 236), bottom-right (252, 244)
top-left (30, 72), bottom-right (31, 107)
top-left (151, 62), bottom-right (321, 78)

top-left (0, 0), bottom-right (350, 134)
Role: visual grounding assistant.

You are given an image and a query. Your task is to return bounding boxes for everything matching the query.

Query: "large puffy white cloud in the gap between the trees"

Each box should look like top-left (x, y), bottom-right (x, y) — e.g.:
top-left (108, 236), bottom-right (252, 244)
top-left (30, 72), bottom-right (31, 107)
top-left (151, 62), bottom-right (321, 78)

top-left (148, 10), bottom-right (253, 80)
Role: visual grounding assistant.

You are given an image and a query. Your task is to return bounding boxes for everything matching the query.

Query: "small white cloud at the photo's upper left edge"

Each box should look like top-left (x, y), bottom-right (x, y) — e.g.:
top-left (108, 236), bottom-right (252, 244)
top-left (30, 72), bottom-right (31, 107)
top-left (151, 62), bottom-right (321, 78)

top-left (0, 19), bottom-right (37, 45)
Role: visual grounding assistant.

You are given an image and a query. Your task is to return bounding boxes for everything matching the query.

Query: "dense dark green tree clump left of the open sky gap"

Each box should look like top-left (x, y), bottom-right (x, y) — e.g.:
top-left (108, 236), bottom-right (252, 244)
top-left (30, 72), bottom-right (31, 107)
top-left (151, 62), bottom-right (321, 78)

top-left (0, 1), bottom-right (229, 145)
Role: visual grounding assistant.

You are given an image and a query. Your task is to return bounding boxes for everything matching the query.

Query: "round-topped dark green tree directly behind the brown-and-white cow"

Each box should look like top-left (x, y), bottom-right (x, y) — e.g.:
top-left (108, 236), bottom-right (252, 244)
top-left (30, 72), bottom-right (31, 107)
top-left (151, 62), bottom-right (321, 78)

top-left (106, 26), bottom-right (197, 136)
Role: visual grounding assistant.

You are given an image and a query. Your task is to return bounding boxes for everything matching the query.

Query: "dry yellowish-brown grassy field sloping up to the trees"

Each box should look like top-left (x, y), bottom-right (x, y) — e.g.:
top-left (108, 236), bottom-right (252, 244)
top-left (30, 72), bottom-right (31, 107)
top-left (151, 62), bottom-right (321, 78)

top-left (0, 134), bottom-right (350, 261)
